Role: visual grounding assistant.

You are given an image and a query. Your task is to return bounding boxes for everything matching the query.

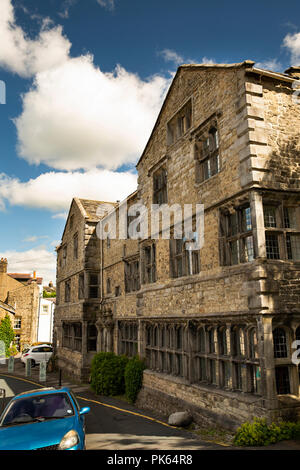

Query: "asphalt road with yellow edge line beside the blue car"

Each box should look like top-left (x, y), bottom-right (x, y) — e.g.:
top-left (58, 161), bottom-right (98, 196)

top-left (0, 371), bottom-right (224, 450)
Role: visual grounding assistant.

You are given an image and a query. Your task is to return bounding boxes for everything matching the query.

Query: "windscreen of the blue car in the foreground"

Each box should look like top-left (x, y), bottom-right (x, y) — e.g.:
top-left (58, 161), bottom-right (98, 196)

top-left (0, 392), bottom-right (74, 426)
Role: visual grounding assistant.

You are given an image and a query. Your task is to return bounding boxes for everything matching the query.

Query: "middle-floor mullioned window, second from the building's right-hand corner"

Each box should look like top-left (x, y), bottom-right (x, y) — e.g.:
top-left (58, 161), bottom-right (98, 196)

top-left (170, 239), bottom-right (200, 278)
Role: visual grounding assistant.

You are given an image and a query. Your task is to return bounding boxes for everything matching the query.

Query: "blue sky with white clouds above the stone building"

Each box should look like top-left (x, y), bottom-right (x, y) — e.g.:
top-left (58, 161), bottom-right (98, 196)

top-left (0, 0), bottom-right (300, 282)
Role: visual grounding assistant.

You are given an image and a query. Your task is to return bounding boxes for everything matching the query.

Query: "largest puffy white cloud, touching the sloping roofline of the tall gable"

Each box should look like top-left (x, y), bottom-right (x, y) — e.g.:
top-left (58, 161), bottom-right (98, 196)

top-left (15, 55), bottom-right (169, 170)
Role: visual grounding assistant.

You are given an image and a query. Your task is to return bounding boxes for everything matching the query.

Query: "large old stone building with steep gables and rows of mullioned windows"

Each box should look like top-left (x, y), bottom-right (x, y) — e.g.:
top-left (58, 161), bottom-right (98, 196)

top-left (56, 61), bottom-right (300, 427)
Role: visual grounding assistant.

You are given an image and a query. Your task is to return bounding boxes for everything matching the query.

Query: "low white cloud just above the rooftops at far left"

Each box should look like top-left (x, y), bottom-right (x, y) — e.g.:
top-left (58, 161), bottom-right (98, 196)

top-left (0, 247), bottom-right (56, 284)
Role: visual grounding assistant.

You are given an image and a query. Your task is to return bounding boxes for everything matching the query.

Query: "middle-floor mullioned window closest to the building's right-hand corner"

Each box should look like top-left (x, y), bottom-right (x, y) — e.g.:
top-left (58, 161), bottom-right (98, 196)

top-left (219, 205), bottom-right (255, 266)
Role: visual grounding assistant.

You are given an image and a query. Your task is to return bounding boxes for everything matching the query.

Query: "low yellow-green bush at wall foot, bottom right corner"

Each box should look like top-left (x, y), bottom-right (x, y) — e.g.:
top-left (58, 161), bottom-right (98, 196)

top-left (233, 418), bottom-right (300, 446)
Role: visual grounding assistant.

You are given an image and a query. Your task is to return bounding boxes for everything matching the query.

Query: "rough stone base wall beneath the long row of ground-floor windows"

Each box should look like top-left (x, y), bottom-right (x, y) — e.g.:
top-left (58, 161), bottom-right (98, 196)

top-left (136, 370), bottom-right (268, 430)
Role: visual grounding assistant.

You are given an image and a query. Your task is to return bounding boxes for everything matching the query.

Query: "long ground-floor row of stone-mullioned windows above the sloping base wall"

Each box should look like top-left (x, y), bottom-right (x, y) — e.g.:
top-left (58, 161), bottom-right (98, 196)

top-left (144, 320), bottom-right (262, 396)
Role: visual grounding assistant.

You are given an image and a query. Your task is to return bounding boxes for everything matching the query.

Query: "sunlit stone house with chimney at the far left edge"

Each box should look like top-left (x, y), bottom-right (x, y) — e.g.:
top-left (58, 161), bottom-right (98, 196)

top-left (0, 258), bottom-right (40, 350)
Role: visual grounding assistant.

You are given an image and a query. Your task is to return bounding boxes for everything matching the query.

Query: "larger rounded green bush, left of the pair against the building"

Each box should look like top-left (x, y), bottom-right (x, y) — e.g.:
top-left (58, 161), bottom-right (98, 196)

top-left (91, 352), bottom-right (128, 396)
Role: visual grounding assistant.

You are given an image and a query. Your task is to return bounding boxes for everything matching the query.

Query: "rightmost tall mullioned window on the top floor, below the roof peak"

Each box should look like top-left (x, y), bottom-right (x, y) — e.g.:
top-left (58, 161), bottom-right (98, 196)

top-left (195, 126), bottom-right (221, 183)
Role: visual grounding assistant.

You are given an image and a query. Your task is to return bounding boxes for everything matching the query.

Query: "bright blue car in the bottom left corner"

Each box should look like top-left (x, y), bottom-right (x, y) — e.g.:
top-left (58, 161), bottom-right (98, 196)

top-left (0, 387), bottom-right (90, 450)
